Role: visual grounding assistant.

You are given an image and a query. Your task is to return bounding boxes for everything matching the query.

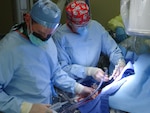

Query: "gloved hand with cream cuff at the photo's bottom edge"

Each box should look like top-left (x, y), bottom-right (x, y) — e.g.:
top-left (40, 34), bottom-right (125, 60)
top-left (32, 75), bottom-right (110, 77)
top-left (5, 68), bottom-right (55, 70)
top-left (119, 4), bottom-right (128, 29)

top-left (21, 102), bottom-right (53, 113)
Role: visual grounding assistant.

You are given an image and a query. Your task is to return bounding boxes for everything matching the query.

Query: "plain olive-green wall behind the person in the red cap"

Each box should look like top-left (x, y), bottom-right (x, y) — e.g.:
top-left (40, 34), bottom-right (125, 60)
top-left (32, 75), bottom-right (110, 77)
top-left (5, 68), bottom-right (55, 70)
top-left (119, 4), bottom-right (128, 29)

top-left (61, 0), bottom-right (120, 29)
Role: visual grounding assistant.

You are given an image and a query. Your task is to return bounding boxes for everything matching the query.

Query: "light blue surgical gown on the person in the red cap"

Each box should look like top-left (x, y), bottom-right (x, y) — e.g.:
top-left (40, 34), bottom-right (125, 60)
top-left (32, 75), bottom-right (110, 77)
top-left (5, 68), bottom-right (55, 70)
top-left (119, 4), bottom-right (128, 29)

top-left (53, 20), bottom-right (123, 79)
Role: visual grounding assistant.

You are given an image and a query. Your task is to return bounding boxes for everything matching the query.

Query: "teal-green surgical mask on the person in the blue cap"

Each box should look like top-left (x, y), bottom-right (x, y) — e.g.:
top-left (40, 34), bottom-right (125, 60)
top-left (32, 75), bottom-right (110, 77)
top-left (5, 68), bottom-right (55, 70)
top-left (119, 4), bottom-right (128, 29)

top-left (28, 33), bottom-right (47, 46)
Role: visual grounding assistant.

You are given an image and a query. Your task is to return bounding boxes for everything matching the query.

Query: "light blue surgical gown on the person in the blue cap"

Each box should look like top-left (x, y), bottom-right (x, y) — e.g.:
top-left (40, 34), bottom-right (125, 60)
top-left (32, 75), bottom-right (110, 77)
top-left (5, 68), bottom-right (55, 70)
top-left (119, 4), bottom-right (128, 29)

top-left (0, 31), bottom-right (76, 113)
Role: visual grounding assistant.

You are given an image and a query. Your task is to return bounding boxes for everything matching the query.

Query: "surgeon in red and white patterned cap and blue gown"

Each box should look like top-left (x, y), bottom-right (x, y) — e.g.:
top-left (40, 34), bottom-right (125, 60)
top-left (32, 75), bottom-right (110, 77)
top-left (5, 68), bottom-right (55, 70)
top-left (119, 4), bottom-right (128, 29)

top-left (53, 1), bottom-right (125, 85)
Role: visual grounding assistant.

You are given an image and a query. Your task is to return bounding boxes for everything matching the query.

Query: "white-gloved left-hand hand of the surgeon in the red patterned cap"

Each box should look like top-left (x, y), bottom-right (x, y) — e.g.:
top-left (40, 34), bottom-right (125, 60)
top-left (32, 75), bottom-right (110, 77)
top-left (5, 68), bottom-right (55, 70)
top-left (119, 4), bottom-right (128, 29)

top-left (85, 67), bottom-right (109, 82)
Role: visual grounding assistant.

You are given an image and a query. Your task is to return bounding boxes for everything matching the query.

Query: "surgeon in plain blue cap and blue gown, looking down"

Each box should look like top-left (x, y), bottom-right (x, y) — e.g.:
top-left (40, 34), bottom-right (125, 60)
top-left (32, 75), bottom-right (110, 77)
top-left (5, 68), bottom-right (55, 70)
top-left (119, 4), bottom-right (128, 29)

top-left (0, 0), bottom-right (97, 113)
